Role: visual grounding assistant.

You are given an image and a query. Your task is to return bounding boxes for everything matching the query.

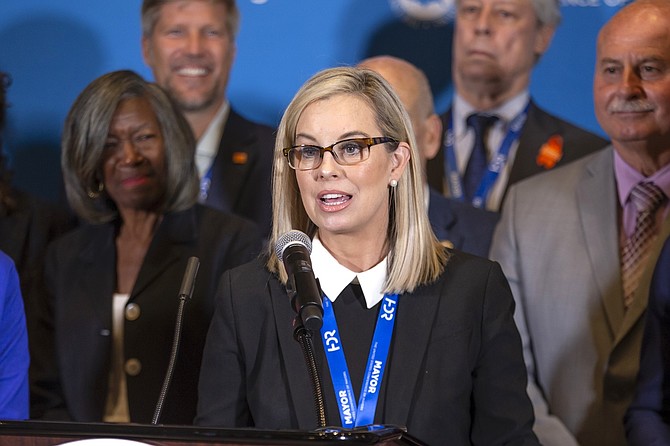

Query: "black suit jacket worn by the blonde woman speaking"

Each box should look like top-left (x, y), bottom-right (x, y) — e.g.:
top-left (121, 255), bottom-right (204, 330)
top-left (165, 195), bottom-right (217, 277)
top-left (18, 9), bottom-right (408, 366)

top-left (196, 251), bottom-right (538, 445)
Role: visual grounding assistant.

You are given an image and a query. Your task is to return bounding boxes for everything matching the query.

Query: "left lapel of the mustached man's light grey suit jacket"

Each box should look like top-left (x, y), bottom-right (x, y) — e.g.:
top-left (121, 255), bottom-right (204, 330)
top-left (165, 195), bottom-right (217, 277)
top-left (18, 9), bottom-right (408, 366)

top-left (577, 149), bottom-right (624, 335)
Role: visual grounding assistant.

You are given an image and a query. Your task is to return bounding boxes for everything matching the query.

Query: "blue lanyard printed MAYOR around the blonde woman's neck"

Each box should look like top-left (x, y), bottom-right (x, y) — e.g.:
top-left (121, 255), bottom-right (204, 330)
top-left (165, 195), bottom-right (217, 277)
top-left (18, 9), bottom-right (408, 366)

top-left (321, 294), bottom-right (398, 428)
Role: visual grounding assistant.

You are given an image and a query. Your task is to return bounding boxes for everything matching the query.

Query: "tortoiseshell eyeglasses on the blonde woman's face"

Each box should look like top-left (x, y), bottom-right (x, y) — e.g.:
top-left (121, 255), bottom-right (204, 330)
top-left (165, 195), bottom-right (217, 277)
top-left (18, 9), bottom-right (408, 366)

top-left (283, 136), bottom-right (398, 170)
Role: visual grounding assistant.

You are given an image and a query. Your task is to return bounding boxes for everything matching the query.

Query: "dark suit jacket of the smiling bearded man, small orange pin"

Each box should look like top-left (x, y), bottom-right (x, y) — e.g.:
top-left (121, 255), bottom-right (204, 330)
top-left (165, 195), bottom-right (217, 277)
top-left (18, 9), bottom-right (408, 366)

top-left (205, 108), bottom-right (275, 235)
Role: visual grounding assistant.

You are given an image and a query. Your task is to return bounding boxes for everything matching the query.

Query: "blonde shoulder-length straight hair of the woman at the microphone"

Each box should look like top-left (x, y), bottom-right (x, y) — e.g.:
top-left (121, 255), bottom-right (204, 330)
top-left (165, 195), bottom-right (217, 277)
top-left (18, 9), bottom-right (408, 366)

top-left (267, 67), bottom-right (447, 293)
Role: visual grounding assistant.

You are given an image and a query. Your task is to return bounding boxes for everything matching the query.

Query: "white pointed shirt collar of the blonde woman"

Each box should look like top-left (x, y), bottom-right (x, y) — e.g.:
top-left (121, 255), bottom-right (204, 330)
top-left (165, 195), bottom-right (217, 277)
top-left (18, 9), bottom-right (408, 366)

top-left (310, 237), bottom-right (387, 309)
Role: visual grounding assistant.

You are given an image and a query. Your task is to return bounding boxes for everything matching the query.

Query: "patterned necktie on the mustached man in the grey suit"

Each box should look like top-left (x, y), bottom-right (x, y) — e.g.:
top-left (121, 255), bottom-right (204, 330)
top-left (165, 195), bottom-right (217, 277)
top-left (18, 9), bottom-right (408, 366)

top-left (621, 181), bottom-right (667, 308)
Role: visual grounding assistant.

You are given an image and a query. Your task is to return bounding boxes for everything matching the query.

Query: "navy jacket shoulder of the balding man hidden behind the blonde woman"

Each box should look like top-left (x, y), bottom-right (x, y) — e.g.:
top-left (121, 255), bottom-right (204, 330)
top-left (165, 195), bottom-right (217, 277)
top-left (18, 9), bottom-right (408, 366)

top-left (428, 187), bottom-right (500, 257)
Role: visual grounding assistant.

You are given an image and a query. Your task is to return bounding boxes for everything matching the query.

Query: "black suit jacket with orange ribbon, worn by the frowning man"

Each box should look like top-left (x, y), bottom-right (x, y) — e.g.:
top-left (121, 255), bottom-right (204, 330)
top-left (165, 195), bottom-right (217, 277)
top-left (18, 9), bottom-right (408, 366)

top-left (427, 100), bottom-right (607, 206)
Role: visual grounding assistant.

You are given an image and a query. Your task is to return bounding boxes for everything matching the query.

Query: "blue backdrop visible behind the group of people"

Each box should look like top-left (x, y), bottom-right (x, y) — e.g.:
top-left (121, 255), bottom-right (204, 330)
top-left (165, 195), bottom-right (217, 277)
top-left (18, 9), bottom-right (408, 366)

top-left (0, 0), bottom-right (626, 199)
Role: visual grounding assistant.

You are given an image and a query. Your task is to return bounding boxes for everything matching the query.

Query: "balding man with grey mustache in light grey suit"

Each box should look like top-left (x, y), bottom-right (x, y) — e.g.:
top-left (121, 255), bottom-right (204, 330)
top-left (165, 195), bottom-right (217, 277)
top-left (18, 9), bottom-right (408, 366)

top-left (491, 0), bottom-right (670, 446)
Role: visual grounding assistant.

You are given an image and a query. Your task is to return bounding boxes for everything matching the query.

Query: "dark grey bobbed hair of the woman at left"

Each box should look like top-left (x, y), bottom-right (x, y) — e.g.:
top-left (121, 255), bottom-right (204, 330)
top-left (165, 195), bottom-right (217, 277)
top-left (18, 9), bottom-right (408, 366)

top-left (61, 70), bottom-right (198, 223)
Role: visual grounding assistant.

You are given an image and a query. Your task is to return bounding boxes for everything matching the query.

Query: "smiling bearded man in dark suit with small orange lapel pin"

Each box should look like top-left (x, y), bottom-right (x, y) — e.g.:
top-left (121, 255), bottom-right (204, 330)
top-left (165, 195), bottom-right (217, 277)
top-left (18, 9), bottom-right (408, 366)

top-left (142, 0), bottom-right (274, 237)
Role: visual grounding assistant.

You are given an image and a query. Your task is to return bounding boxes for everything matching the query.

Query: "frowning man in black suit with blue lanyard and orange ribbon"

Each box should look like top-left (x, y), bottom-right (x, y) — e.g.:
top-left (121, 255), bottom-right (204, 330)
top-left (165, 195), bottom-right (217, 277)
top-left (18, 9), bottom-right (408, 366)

top-left (428, 0), bottom-right (607, 211)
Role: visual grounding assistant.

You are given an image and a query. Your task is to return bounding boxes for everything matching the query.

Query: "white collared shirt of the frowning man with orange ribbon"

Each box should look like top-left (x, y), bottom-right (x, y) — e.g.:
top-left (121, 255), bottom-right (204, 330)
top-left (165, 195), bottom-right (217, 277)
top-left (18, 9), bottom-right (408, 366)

top-left (452, 90), bottom-right (530, 211)
